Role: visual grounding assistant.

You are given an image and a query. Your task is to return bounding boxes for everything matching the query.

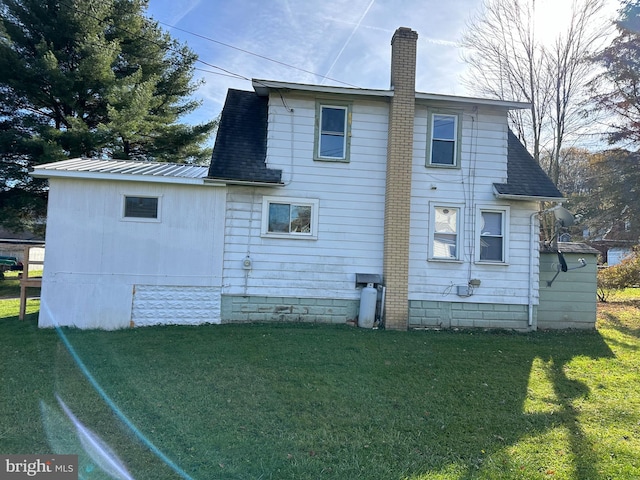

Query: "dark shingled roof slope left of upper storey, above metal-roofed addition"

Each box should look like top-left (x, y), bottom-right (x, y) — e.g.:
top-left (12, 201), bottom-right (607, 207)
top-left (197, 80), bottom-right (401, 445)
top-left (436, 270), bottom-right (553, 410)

top-left (208, 89), bottom-right (282, 184)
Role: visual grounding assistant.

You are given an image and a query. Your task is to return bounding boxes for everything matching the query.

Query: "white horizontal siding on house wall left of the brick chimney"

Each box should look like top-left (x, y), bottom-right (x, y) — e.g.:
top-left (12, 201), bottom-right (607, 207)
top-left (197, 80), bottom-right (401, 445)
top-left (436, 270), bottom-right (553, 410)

top-left (223, 95), bottom-right (389, 299)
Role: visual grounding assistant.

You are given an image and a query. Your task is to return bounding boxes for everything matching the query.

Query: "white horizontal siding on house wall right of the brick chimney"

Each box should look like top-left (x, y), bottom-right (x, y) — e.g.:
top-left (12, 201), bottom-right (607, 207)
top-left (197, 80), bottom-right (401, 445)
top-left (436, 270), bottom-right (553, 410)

top-left (409, 107), bottom-right (538, 305)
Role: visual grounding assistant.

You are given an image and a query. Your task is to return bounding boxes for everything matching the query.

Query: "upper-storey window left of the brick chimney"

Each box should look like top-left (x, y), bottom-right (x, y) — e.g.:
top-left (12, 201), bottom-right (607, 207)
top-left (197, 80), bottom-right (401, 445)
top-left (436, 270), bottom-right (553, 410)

top-left (315, 105), bottom-right (349, 162)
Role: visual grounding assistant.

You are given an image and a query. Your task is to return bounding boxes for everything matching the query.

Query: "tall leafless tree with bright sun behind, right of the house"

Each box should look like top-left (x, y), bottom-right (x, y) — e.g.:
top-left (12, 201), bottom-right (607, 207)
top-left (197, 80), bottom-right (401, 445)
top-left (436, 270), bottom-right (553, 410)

top-left (462, 0), bottom-right (607, 183)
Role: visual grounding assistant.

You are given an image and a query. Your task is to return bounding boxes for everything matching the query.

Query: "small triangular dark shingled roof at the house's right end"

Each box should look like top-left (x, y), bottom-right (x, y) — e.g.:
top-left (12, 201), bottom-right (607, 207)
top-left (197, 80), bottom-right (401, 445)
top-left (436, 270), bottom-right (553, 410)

top-left (493, 130), bottom-right (563, 199)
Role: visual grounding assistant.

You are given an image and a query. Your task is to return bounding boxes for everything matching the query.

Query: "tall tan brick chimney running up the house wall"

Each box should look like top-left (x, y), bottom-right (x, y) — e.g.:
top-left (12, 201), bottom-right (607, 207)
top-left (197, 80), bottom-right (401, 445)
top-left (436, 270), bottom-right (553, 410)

top-left (383, 27), bottom-right (418, 330)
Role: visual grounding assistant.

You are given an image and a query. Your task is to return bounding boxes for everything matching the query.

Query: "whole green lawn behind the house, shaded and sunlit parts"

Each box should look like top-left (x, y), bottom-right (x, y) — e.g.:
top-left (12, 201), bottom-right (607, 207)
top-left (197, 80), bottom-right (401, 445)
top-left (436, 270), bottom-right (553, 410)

top-left (0, 296), bottom-right (640, 480)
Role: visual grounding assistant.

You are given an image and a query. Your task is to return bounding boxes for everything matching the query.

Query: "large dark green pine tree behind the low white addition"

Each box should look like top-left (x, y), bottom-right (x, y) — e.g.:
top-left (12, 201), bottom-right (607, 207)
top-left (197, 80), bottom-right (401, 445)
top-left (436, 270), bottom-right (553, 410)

top-left (0, 0), bottom-right (215, 229)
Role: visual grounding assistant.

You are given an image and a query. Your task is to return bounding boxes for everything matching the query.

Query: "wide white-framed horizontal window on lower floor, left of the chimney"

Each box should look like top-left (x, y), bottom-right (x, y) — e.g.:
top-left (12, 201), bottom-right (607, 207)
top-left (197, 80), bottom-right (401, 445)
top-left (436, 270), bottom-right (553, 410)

top-left (262, 197), bottom-right (318, 240)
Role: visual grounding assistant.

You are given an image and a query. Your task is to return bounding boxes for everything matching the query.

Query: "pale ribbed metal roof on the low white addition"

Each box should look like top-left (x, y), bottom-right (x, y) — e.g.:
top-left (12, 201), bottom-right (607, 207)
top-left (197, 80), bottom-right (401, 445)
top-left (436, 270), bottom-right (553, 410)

top-left (32, 158), bottom-right (209, 183)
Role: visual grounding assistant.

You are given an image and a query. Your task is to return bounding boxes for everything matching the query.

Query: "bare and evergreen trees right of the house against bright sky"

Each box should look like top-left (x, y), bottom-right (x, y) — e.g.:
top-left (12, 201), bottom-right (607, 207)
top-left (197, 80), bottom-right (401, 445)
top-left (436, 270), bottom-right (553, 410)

top-left (463, 0), bottom-right (640, 246)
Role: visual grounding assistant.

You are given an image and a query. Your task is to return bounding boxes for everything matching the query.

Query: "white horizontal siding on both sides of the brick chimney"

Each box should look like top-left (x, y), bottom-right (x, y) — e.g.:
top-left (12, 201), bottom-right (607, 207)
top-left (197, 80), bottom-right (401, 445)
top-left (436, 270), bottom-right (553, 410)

top-left (223, 93), bottom-right (537, 305)
